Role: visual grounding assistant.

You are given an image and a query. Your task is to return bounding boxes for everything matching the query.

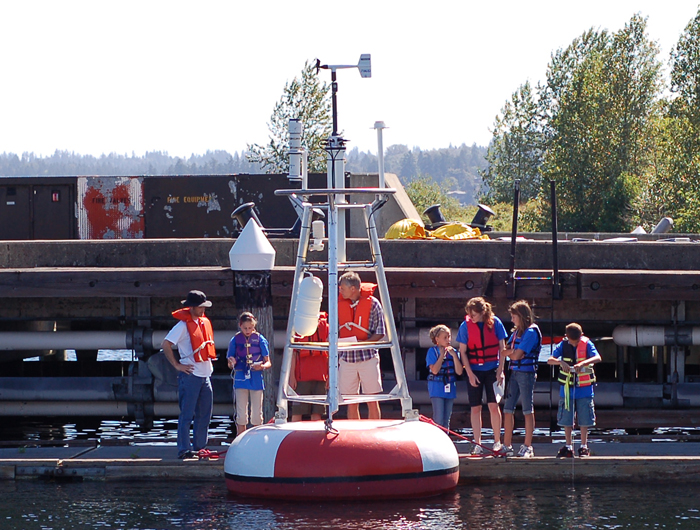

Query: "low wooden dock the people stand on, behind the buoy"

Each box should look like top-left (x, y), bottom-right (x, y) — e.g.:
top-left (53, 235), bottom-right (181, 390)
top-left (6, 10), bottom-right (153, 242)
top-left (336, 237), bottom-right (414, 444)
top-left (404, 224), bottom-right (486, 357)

top-left (0, 442), bottom-right (700, 484)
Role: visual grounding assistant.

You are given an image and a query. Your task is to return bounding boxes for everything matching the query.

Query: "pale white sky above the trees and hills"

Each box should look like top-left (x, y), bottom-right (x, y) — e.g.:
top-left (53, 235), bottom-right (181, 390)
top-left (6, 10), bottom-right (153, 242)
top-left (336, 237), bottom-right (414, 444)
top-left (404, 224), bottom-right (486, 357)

top-left (0, 0), bottom-right (698, 156)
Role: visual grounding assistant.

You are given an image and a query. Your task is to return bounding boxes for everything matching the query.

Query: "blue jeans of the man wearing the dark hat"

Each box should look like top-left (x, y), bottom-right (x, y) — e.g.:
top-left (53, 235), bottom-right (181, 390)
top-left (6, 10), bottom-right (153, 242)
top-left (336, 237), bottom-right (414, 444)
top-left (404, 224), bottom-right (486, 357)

top-left (177, 372), bottom-right (214, 456)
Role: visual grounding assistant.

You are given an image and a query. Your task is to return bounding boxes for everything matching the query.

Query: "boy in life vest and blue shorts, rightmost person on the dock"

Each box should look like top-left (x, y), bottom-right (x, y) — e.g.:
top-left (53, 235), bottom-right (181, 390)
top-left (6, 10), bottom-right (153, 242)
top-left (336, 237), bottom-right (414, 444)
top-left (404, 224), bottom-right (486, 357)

top-left (547, 322), bottom-right (601, 458)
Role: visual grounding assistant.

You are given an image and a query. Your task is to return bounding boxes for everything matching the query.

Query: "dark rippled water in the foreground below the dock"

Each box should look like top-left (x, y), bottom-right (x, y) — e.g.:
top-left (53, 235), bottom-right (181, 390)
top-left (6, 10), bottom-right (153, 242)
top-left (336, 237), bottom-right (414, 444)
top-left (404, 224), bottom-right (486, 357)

top-left (0, 481), bottom-right (700, 530)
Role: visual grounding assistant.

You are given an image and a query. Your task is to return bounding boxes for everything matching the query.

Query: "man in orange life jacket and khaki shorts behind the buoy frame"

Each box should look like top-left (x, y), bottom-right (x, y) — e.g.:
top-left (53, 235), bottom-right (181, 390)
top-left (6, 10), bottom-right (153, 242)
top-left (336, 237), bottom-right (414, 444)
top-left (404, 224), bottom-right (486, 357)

top-left (338, 272), bottom-right (386, 420)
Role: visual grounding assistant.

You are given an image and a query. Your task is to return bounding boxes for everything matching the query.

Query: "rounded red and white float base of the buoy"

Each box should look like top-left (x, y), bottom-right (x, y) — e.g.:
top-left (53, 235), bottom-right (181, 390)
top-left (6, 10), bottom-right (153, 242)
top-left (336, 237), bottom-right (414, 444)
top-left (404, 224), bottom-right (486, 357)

top-left (224, 420), bottom-right (459, 500)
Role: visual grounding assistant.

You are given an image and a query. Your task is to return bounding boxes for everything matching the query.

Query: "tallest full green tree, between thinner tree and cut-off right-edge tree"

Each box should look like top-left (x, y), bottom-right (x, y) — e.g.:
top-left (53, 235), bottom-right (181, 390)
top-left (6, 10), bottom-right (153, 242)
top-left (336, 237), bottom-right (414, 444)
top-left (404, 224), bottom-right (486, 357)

top-left (542, 15), bottom-right (661, 231)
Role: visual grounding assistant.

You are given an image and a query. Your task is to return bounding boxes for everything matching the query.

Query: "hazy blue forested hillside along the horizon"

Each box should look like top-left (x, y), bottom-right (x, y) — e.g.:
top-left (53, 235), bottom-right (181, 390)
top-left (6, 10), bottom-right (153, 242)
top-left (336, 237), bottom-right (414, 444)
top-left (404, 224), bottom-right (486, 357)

top-left (0, 144), bottom-right (487, 204)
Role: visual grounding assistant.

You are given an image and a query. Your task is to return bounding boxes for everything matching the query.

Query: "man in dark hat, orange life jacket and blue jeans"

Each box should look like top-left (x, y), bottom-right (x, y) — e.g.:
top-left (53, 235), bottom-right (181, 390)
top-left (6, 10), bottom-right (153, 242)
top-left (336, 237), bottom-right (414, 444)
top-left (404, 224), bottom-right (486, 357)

top-left (162, 291), bottom-right (216, 459)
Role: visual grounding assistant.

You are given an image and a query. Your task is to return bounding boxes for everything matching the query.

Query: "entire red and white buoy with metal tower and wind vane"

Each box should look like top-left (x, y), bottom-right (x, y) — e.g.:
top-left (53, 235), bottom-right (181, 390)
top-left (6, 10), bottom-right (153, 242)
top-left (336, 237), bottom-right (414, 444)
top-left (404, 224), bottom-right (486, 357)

top-left (224, 54), bottom-right (459, 500)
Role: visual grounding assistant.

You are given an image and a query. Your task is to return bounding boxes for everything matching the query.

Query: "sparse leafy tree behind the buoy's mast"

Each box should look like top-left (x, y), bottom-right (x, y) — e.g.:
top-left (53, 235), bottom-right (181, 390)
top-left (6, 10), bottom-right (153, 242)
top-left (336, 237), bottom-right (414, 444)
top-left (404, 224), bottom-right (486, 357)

top-left (246, 61), bottom-right (333, 173)
